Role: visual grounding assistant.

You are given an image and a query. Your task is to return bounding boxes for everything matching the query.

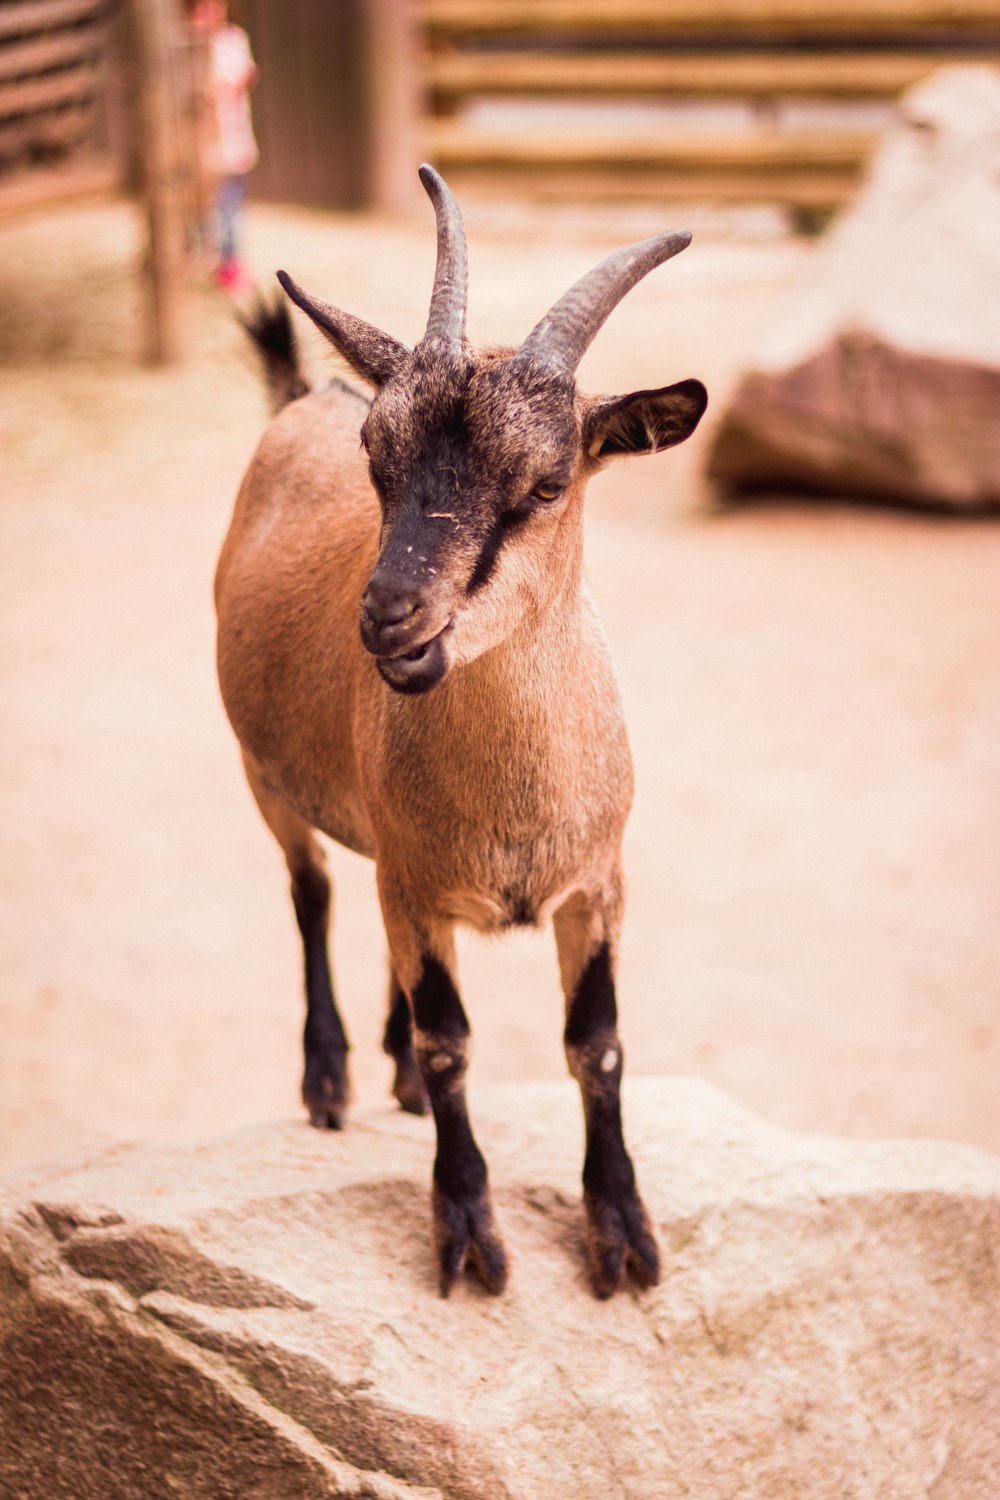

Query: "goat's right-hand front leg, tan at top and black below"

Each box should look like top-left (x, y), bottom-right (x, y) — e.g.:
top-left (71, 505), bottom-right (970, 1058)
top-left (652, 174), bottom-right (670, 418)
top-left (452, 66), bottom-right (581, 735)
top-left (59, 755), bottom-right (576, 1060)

top-left (555, 882), bottom-right (660, 1298)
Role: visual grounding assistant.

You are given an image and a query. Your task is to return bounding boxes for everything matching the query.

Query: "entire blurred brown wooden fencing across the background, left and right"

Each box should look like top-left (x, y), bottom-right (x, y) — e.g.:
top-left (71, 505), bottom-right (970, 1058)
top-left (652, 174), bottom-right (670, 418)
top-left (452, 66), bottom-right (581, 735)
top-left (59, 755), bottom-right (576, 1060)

top-left (0, 0), bottom-right (1000, 220)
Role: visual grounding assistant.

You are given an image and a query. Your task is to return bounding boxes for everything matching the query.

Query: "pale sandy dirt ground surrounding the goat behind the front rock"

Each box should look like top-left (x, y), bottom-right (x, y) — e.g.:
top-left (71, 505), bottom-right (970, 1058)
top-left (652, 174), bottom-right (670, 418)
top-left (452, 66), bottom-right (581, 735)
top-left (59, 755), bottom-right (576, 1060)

top-left (0, 193), bottom-right (1000, 1170)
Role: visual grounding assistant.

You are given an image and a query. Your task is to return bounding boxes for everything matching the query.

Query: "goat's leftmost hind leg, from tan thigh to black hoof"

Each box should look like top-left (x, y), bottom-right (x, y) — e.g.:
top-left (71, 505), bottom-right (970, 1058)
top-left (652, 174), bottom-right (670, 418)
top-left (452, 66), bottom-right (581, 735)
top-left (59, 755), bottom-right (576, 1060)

top-left (243, 756), bottom-right (351, 1130)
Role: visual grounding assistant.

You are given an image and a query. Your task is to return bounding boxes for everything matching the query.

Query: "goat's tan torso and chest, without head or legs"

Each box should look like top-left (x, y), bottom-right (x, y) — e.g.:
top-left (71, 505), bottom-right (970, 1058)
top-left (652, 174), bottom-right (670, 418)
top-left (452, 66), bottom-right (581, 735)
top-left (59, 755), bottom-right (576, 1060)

top-left (216, 383), bottom-right (631, 932)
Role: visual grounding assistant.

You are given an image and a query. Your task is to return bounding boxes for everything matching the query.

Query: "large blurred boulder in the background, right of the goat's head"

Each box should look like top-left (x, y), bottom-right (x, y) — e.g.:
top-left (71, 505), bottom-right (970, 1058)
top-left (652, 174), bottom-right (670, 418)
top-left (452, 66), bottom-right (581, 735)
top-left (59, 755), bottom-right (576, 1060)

top-left (709, 65), bottom-right (1000, 509)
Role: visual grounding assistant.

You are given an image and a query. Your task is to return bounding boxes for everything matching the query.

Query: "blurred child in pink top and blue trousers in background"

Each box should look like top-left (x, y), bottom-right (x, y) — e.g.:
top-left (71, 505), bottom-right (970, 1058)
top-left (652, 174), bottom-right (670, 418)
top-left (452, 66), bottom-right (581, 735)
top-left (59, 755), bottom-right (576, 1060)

top-left (187, 0), bottom-right (259, 293)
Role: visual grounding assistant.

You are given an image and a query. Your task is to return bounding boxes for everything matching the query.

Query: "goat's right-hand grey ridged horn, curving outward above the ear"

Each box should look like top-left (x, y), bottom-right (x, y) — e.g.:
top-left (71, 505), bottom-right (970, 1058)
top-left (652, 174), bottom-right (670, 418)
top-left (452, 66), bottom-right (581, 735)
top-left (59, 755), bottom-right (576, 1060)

top-left (519, 230), bottom-right (691, 371)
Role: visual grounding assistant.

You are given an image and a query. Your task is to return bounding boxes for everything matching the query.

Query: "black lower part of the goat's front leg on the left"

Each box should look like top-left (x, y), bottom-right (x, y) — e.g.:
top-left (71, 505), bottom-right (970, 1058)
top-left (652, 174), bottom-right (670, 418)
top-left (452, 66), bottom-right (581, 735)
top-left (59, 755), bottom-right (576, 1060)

top-left (411, 954), bottom-right (507, 1296)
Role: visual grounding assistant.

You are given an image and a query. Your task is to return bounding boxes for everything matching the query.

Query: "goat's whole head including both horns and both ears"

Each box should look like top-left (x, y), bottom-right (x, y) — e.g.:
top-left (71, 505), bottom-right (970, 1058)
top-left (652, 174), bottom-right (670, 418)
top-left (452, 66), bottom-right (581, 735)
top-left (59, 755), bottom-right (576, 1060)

top-left (279, 167), bottom-right (708, 693)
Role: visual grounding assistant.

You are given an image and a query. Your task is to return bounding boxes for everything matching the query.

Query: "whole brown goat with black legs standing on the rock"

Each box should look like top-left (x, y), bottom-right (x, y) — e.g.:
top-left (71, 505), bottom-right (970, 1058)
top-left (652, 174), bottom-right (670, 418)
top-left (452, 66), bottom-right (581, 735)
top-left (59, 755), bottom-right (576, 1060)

top-left (216, 167), bottom-right (706, 1296)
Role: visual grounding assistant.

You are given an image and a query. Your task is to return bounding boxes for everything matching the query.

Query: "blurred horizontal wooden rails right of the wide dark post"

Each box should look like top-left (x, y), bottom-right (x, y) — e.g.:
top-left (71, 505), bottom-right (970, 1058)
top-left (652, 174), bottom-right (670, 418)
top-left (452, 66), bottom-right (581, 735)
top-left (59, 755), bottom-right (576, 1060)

top-left (417, 0), bottom-right (1000, 209)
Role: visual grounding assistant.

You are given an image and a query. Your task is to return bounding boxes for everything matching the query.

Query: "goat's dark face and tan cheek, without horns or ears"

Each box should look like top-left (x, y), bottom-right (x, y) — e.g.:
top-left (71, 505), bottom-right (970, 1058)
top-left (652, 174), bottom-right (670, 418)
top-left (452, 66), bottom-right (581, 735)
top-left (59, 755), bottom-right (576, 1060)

top-left (361, 345), bottom-right (585, 693)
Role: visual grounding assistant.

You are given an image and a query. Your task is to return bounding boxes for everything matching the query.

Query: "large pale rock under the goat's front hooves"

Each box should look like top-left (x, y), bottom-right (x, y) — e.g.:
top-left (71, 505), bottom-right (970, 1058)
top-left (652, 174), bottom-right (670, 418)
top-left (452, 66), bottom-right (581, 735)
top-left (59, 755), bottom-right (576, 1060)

top-left (0, 1079), bottom-right (1000, 1500)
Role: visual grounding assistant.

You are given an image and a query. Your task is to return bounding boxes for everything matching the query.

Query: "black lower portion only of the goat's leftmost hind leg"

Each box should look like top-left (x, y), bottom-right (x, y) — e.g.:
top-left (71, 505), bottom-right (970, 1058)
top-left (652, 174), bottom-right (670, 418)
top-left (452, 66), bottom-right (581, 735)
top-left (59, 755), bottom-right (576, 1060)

top-left (292, 864), bottom-right (351, 1130)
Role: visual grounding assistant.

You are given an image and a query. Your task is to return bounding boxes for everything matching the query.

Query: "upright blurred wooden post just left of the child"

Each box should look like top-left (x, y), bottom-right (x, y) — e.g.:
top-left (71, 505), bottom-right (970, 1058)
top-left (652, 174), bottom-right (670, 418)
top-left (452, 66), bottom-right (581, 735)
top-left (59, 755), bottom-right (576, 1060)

top-left (132, 0), bottom-right (186, 365)
